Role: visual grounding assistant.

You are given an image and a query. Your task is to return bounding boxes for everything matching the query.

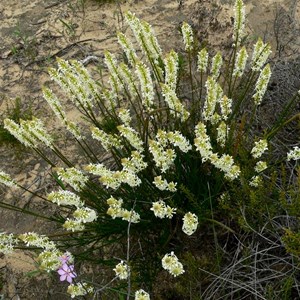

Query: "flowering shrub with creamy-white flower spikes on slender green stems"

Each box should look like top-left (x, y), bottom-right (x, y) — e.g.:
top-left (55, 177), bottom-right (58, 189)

top-left (0, 0), bottom-right (299, 299)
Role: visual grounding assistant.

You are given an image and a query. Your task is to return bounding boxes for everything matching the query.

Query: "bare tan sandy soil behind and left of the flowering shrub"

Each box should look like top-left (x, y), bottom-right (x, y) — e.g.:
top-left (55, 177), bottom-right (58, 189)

top-left (0, 0), bottom-right (300, 299)
